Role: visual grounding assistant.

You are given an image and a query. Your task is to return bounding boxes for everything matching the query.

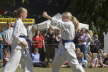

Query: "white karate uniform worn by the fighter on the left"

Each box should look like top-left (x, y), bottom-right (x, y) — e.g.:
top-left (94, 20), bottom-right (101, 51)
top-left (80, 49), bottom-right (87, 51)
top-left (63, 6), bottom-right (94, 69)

top-left (3, 19), bottom-right (32, 72)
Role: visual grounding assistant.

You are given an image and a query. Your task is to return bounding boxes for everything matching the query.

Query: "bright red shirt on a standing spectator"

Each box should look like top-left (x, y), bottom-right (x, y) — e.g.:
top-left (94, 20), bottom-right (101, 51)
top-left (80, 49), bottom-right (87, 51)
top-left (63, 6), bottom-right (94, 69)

top-left (32, 36), bottom-right (44, 48)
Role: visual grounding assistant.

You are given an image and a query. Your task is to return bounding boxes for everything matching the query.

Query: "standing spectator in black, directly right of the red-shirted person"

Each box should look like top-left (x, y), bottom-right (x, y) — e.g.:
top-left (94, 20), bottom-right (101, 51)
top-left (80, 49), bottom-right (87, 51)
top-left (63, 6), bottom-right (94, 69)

top-left (46, 27), bottom-right (56, 62)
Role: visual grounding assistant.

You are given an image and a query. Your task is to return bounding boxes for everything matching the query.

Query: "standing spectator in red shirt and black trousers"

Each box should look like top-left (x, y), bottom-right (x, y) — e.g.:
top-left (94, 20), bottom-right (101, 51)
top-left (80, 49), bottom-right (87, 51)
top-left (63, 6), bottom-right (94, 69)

top-left (32, 30), bottom-right (45, 62)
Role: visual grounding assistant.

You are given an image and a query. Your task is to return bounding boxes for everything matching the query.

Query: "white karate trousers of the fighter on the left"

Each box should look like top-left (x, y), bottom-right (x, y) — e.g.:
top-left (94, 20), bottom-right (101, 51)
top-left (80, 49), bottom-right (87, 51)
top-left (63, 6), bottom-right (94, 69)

top-left (3, 46), bottom-right (32, 72)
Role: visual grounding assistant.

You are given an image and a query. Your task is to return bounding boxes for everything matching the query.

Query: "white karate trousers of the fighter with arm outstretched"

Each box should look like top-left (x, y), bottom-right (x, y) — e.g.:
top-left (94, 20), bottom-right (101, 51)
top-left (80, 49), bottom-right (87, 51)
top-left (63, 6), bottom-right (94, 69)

top-left (52, 42), bottom-right (85, 72)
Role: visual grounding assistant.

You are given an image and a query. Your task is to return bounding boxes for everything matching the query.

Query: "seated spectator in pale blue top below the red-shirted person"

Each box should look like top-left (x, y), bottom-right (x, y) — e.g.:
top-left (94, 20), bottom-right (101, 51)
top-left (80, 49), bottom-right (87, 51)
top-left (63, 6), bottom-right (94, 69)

top-left (32, 48), bottom-right (47, 67)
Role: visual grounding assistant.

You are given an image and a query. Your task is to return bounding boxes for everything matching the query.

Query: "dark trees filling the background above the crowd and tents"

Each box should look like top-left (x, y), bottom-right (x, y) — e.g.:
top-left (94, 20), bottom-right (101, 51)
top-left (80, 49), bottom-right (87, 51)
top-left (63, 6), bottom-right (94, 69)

top-left (0, 0), bottom-right (108, 34)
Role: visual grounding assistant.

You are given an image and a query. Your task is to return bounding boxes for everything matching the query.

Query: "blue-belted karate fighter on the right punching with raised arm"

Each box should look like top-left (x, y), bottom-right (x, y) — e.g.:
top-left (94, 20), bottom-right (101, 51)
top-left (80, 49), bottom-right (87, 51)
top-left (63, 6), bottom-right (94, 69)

top-left (43, 12), bottom-right (85, 72)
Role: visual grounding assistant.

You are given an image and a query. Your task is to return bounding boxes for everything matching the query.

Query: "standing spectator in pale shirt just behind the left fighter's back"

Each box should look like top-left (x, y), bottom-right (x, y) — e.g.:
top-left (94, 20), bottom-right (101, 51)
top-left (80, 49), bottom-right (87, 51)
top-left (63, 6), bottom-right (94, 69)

top-left (3, 23), bottom-right (13, 65)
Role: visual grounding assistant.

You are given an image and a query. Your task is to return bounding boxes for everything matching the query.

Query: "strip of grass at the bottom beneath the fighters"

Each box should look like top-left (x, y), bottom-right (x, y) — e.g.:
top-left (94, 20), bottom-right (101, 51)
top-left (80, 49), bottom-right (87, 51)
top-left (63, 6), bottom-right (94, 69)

top-left (0, 67), bottom-right (108, 72)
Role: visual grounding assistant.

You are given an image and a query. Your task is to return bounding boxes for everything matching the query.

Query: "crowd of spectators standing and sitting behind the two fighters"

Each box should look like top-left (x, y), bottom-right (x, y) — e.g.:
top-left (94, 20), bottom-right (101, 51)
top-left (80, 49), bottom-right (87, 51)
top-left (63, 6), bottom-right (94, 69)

top-left (0, 6), bottom-right (108, 72)
